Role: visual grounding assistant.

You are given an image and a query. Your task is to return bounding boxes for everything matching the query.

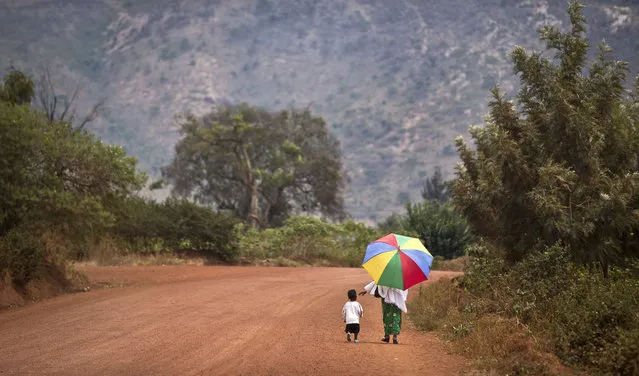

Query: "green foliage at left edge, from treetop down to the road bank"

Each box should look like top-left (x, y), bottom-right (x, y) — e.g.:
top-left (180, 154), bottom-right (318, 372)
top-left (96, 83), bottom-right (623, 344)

top-left (0, 71), bottom-right (146, 286)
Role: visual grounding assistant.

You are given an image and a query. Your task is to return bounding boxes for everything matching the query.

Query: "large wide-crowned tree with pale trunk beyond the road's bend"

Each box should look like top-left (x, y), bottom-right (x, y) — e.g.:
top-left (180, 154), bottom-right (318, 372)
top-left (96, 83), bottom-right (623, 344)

top-left (163, 104), bottom-right (344, 227)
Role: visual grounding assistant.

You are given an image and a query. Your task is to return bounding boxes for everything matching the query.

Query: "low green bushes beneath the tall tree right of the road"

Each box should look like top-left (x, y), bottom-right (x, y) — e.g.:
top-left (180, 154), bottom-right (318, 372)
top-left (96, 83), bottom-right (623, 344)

top-left (450, 245), bottom-right (639, 375)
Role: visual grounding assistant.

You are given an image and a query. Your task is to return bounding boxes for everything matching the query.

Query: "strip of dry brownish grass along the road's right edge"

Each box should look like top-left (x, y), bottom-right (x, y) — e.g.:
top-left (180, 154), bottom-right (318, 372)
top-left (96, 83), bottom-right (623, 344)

top-left (409, 280), bottom-right (571, 375)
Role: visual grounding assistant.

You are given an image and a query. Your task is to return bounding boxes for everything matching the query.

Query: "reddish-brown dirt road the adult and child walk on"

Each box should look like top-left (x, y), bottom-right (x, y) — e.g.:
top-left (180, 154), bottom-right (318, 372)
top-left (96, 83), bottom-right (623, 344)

top-left (0, 266), bottom-right (466, 376)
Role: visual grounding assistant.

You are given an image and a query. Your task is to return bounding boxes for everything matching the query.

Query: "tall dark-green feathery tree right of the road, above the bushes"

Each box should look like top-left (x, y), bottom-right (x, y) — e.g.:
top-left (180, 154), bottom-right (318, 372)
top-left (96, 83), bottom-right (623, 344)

top-left (453, 1), bottom-right (639, 274)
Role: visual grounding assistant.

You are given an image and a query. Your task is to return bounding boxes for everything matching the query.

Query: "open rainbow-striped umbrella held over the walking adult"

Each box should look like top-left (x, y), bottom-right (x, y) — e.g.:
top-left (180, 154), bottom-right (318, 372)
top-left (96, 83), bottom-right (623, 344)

top-left (362, 234), bottom-right (433, 290)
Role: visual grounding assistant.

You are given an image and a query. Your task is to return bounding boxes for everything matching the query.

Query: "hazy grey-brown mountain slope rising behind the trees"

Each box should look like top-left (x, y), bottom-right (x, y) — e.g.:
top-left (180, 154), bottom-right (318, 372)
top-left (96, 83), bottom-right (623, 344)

top-left (0, 0), bottom-right (639, 220)
